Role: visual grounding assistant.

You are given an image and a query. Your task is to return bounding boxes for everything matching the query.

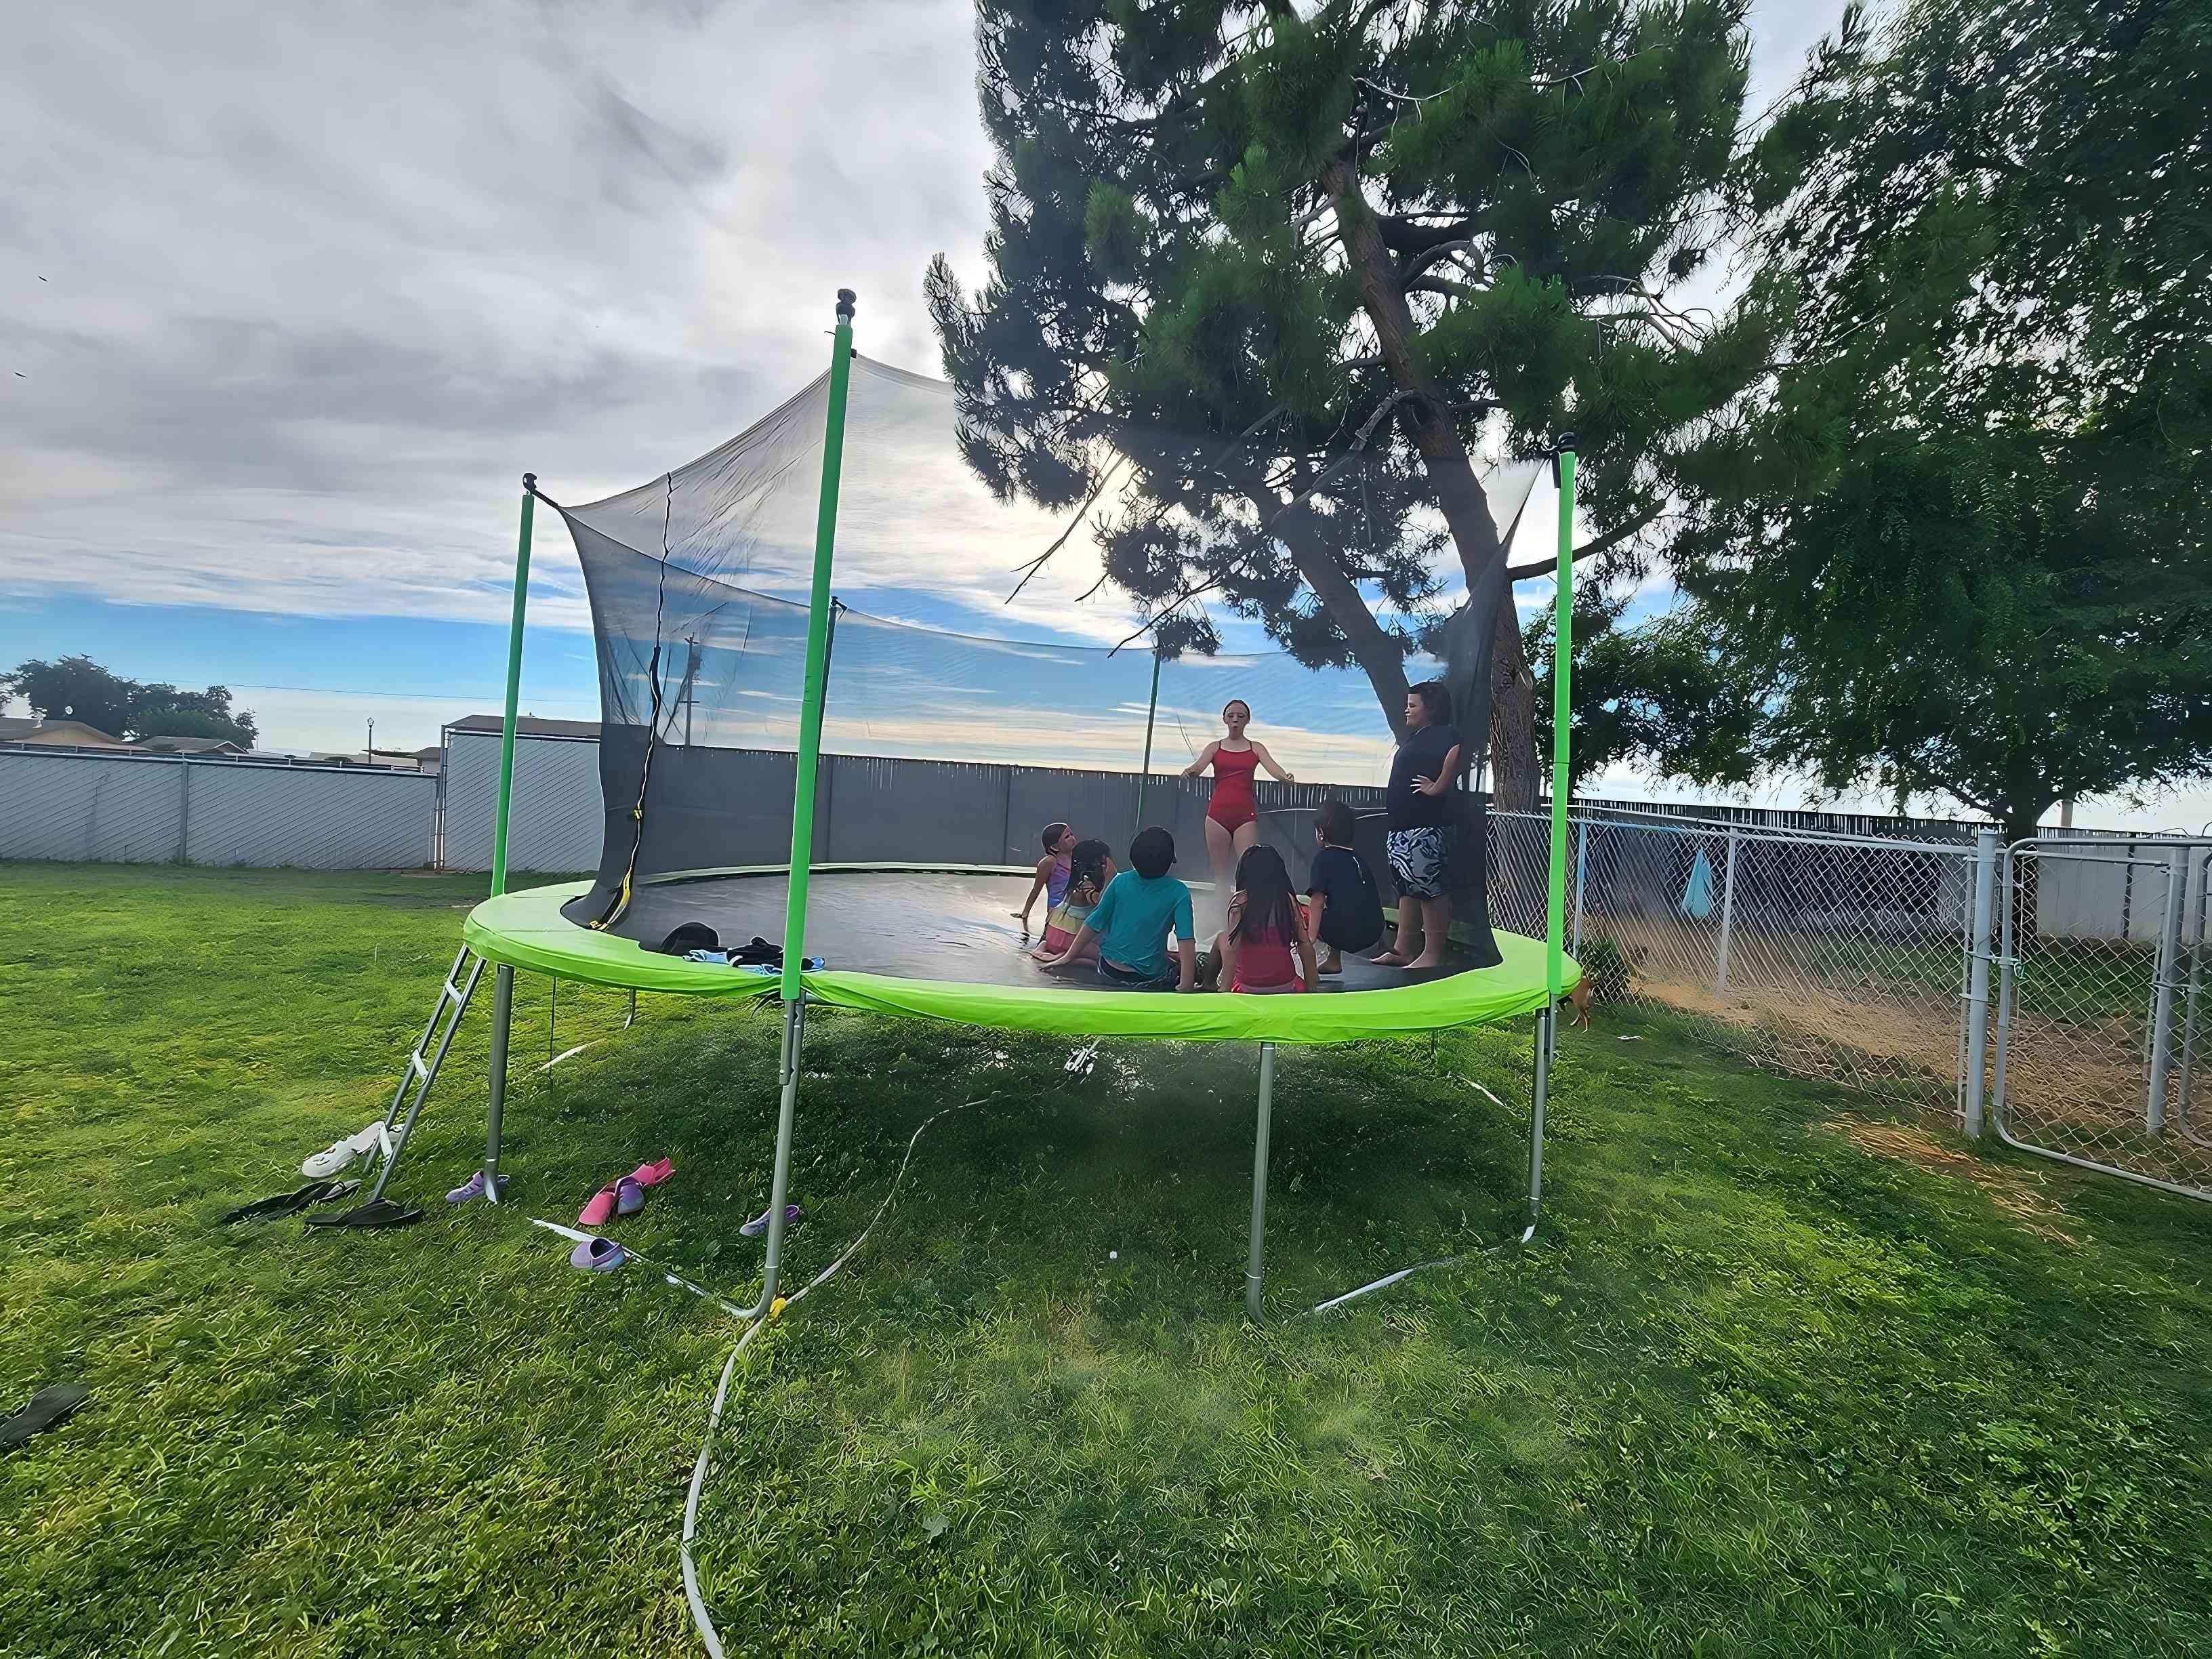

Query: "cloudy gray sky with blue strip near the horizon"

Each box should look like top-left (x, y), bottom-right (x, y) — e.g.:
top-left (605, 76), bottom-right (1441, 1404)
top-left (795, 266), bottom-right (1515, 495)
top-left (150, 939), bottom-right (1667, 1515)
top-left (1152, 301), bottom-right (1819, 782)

top-left (0, 0), bottom-right (2194, 827)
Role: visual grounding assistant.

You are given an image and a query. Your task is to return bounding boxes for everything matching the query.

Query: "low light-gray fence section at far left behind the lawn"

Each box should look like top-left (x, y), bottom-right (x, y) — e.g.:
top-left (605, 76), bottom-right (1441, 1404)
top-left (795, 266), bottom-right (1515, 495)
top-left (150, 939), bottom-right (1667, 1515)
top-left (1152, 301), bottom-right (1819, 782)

top-left (0, 747), bottom-right (438, 869)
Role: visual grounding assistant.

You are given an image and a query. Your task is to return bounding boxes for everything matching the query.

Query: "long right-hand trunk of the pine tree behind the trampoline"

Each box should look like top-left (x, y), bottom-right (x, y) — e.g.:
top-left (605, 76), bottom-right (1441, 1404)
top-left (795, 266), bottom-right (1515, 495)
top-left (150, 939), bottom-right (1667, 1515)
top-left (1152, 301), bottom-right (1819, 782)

top-left (1321, 161), bottom-right (1533, 774)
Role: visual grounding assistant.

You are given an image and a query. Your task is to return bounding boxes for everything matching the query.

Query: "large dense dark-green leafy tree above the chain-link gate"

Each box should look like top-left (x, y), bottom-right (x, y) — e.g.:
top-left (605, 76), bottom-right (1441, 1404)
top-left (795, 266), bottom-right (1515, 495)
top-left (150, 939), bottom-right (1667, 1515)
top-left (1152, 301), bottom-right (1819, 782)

top-left (1670, 0), bottom-right (2212, 838)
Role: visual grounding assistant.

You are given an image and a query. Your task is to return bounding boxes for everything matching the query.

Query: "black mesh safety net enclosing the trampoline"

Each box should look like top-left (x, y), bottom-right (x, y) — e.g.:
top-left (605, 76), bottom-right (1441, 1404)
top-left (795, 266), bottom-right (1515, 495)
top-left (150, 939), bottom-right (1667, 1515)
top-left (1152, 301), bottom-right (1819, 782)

top-left (548, 356), bottom-right (1544, 964)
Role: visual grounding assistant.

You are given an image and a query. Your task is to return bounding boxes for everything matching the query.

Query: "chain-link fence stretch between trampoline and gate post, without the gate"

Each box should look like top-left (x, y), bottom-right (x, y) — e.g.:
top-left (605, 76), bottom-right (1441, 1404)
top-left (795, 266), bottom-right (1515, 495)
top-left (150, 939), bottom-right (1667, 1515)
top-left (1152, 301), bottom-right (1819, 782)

top-left (1491, 814), bottom-right (1995, 1113)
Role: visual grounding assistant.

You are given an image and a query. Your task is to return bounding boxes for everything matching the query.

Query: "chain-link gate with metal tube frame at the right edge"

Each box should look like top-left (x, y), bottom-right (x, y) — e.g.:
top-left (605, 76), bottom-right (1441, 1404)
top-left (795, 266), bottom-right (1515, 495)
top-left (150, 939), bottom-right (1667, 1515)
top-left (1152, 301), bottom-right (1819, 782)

top-left (1995, 838), bottom-right (2212, 1199)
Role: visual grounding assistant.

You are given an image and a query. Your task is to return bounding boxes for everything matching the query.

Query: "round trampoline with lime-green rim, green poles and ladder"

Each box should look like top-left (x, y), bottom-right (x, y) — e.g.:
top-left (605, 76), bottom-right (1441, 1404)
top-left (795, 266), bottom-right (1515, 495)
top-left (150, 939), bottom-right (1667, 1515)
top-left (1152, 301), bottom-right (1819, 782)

top-left (371, 290), bottom-right (1579, 1318)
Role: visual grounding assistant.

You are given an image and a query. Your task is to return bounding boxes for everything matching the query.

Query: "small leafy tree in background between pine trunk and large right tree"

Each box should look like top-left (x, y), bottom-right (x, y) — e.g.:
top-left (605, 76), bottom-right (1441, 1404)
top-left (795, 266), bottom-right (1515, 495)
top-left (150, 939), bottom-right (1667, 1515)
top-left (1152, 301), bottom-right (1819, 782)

top-left (1526, 590), bottom-right (1767, 792)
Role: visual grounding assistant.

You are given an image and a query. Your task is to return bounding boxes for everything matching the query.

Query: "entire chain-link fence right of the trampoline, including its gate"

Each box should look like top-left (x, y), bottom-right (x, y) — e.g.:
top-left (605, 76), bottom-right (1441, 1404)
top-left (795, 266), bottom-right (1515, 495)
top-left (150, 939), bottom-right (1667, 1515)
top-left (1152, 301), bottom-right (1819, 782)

top-left (1489, 812), bottom-right (2212, 1199)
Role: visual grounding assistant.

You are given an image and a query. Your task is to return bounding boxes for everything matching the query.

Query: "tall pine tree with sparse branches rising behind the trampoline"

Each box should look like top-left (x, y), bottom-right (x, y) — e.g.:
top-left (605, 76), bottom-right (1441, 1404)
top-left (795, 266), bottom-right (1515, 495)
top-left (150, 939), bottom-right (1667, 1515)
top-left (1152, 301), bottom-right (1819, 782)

top-left (927, 0), bottom-right (1787, 805)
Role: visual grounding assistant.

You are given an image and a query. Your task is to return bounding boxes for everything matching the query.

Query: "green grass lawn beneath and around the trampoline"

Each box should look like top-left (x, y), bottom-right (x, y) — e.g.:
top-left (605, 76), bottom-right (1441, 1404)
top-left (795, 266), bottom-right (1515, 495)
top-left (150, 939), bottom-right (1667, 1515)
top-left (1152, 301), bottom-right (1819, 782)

top-left (0, 865), bottom-right (2212, 1657)
